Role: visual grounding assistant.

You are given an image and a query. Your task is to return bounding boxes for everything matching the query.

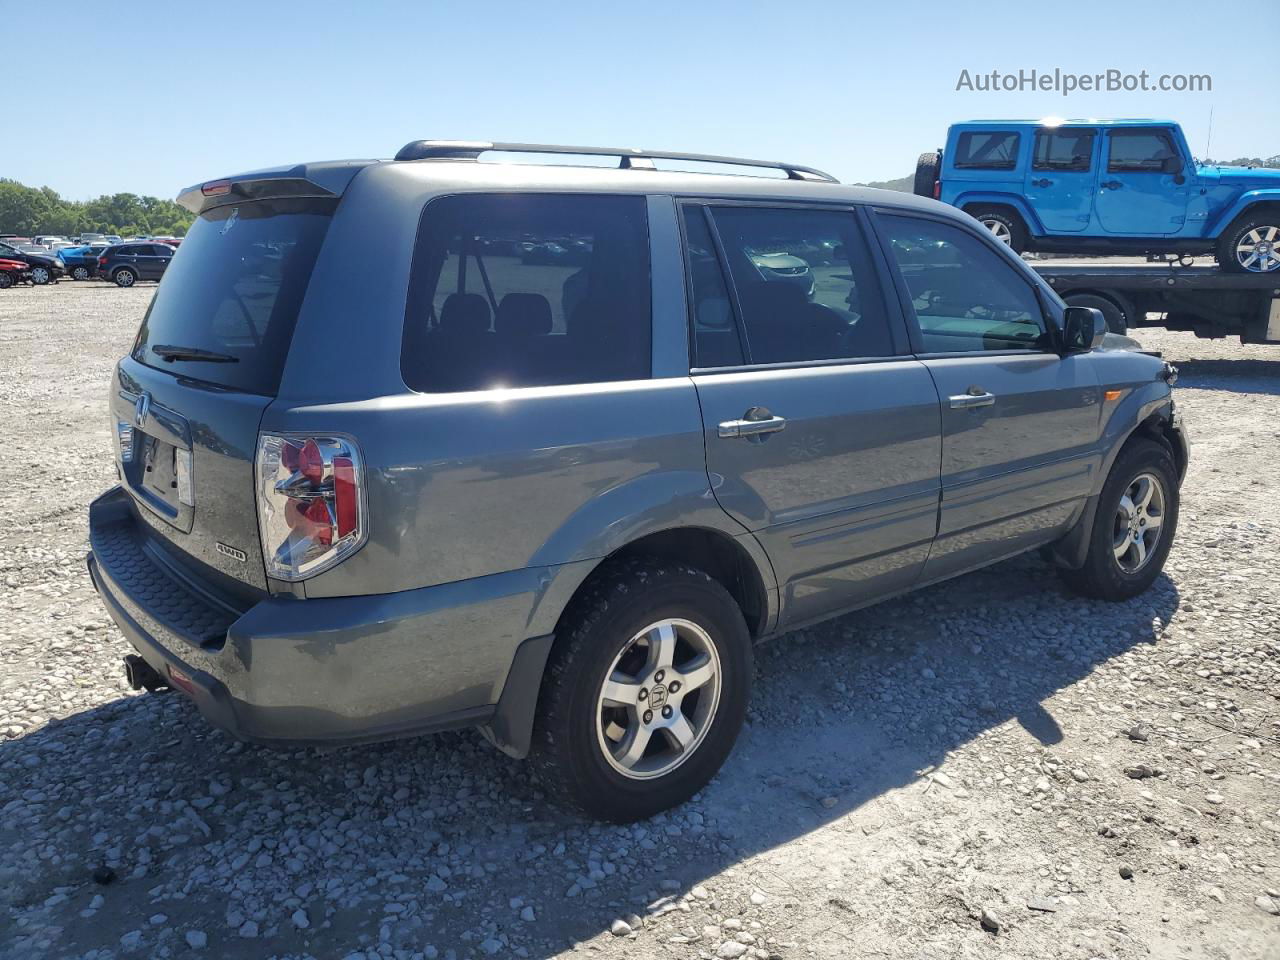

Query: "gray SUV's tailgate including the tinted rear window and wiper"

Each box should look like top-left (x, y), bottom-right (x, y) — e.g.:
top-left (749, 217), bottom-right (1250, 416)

top-left (110, 198), bottom-right (335, 591)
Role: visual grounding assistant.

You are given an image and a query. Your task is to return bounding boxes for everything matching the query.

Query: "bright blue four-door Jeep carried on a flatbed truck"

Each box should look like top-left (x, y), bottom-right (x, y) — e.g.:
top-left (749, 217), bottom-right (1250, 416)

top-left (914, 119), bottom-right (1280, 274)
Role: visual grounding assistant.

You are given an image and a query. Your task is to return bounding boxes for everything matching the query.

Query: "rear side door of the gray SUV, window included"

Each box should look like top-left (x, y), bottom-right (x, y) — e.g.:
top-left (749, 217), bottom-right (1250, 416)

top-left (681, 202), bottom-right (941, 626)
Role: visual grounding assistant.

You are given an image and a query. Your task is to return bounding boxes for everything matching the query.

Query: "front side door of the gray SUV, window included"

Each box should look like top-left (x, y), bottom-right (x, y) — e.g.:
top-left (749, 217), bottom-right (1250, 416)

top-left (874, 210), bottom-right (1101, 581)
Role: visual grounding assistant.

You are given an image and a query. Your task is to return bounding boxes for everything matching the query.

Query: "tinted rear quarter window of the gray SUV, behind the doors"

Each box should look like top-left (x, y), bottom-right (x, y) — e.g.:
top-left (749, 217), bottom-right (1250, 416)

top-left (401, 193), bottom-right (652, 393)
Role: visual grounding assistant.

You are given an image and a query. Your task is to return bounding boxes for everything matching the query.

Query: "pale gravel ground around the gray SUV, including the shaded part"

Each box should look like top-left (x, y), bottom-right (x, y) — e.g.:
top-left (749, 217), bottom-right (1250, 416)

top-left (0, 283), bottom-right (1280, 960)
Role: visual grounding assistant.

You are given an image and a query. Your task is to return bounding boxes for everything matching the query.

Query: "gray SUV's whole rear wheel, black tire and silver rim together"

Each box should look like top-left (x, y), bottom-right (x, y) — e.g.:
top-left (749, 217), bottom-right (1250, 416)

top-left (530, 558), bottom-right (753, 823)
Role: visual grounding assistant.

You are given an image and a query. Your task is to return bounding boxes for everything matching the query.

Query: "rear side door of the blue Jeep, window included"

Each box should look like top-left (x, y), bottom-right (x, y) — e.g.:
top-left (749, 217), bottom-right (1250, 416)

top-left (1025, 127), bottom-right (1097, 233)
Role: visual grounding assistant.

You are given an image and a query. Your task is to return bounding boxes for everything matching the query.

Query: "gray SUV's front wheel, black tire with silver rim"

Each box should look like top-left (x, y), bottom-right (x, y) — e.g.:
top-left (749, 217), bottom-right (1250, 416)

top-left (1059, 439), bottom-right (1179, 602)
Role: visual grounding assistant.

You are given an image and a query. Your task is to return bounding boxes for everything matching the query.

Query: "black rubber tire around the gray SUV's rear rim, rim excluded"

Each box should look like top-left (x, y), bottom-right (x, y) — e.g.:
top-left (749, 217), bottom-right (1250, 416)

top-left (530, 558), bottom-right (753, 823)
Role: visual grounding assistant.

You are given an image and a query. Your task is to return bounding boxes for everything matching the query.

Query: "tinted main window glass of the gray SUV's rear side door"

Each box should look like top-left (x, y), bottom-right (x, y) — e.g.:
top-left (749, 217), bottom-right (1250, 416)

top-left (713, 207), bottom-right (893, 364)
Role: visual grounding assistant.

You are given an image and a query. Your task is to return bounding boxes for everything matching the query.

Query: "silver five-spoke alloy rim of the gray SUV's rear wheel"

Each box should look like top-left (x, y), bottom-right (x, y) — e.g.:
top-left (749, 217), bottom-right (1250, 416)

top-left (595, 618), bottom-right (722, 780)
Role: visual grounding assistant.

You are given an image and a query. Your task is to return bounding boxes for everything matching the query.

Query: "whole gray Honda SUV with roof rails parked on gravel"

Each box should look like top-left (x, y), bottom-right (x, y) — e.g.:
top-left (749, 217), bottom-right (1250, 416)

top-left (88, 141), bottom-right (1188, 822)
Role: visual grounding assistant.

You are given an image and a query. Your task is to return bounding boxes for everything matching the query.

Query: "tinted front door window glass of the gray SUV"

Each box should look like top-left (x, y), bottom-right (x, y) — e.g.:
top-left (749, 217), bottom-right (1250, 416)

top-left (879, 216), bottom-right (1051, 353)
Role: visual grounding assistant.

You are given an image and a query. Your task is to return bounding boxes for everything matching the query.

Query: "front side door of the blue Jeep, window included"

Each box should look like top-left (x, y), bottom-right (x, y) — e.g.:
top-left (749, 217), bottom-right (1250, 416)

top-left (1094, 127), bottom-right (1193, 237)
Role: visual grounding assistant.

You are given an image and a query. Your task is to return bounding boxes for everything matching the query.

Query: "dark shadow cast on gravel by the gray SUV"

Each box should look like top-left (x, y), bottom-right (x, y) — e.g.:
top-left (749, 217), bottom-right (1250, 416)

top-left (0, 558), bottom-right (1178, 957)
